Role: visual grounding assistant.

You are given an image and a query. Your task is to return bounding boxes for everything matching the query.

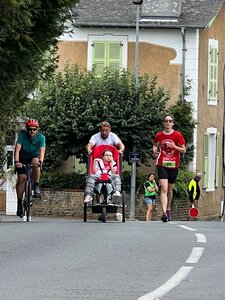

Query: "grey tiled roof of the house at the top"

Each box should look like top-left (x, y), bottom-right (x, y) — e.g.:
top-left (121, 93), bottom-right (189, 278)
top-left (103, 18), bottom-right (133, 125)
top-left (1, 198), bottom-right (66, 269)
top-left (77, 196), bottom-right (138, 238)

top-left (74, 0), bottom-right (225, 28)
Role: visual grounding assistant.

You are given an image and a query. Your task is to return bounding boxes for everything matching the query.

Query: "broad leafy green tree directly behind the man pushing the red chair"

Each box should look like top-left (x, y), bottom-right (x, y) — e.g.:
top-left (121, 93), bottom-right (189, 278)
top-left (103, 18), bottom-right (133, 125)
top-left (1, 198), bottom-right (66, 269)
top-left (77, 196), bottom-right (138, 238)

top-left (24, 66), bottom-right (169, 167)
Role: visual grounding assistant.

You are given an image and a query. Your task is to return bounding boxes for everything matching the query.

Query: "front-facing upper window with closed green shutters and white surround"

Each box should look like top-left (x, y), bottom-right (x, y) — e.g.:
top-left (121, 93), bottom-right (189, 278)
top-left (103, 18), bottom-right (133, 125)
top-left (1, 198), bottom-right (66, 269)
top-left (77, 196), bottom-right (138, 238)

top-left (88, 35), bottom-right (127, 75)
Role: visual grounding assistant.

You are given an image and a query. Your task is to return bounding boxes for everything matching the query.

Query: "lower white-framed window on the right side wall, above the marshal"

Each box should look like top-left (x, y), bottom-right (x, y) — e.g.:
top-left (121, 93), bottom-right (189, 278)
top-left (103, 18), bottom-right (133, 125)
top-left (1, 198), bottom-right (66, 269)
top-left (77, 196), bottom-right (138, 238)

top-left (203, 127), bottom-right (221, 192)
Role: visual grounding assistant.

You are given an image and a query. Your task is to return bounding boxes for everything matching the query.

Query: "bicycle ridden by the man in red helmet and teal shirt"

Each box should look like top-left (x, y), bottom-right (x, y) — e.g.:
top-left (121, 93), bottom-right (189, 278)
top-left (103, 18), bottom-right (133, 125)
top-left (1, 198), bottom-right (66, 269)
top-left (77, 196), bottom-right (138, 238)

top-left (23, 164), bottom-right (41, 222)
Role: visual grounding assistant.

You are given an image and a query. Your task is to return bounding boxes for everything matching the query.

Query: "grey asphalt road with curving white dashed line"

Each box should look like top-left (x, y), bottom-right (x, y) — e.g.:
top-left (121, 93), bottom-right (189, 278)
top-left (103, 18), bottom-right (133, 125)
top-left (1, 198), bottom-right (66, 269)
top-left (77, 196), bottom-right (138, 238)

top-left (0, 216), bottom-right (225, 300)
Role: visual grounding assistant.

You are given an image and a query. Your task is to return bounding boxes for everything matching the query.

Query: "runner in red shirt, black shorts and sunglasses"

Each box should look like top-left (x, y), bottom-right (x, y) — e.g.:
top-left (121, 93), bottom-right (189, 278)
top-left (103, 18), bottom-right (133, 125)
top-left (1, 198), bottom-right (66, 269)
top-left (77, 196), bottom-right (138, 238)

top-left (153, 115), bottom-right (186, 222)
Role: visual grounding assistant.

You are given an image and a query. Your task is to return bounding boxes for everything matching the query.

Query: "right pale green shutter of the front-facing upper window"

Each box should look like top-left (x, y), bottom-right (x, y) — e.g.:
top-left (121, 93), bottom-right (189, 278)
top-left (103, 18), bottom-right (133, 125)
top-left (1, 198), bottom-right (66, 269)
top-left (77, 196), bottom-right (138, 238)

top-left (108, 42), bottom-right (122, 69)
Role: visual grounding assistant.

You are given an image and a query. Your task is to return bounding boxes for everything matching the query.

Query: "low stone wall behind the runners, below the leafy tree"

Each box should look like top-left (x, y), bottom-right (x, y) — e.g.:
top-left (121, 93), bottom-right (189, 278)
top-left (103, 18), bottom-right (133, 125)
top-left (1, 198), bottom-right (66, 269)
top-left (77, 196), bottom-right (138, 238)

top-left (32, 190), bottom-right (192, 220)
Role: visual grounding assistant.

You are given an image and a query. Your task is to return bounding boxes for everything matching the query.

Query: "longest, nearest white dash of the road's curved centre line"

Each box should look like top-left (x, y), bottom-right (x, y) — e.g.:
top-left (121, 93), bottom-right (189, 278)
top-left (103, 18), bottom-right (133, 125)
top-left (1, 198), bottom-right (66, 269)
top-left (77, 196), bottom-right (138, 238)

top-left (138, 266), bottom-right (193, 300)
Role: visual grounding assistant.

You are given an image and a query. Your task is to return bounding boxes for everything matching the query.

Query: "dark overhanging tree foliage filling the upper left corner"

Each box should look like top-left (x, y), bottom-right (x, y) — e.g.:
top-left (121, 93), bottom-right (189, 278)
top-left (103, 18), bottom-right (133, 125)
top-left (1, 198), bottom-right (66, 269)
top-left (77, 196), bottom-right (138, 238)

top-left (0, 0), bottom-right (77, 169)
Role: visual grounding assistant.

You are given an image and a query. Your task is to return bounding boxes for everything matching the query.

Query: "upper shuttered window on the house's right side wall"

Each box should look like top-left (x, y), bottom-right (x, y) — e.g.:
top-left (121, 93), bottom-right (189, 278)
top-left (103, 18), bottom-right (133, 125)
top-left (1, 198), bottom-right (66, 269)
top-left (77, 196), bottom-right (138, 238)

top-left (208, 39), bottom-right (219, 105)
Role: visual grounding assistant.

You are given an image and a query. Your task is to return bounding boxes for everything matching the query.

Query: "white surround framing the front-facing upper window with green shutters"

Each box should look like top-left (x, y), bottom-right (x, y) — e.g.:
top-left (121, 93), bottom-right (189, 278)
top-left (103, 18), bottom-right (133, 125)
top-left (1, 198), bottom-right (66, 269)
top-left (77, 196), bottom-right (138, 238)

top-left (87, 34), bottom-right (128, 70)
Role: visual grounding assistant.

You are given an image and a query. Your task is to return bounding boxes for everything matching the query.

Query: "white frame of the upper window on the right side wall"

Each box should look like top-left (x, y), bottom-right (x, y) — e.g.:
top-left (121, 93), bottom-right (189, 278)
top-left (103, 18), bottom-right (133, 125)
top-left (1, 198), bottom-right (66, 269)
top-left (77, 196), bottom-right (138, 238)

top-left (207, 39), bottom-right (219, 105)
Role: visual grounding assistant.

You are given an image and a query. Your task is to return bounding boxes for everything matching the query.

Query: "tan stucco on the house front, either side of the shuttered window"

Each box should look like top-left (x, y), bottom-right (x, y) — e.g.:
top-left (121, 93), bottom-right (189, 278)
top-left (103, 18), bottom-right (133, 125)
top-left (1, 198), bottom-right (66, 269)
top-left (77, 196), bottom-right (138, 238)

top-left (58, 41), bottom-right (181, 104)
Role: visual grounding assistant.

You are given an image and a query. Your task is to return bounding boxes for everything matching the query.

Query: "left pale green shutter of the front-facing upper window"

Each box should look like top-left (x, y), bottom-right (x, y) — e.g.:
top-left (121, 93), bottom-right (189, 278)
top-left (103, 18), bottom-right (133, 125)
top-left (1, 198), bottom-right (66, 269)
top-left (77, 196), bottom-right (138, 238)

top-left (92, 41), bottom-right (107, 75)
